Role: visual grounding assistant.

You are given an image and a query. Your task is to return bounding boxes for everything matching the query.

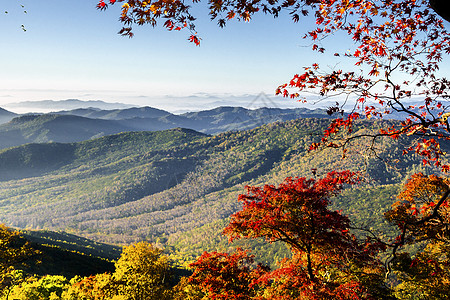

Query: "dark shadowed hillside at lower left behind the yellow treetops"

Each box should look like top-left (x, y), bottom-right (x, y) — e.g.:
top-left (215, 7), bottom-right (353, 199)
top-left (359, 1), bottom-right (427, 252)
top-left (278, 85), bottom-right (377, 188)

top-left (1, 227), bottom-right (118, 278)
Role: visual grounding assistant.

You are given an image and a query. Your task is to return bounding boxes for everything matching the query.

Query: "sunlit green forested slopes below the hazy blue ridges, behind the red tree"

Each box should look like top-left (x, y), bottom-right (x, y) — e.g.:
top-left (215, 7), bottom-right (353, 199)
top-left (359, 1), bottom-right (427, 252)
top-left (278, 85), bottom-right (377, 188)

top-left (0, 119), bottom-right (442, 258)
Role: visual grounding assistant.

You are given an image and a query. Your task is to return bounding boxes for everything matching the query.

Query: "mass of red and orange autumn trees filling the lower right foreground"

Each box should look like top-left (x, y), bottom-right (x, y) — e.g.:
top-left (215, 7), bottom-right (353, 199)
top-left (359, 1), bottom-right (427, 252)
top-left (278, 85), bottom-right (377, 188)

top-left (182, 171), bottom-right (450, 299)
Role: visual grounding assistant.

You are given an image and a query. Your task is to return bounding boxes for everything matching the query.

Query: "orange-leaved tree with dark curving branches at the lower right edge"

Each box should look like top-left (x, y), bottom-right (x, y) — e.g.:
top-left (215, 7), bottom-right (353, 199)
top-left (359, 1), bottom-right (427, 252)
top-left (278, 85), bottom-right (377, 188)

top-left (385, 174), bottom-right (450, 299)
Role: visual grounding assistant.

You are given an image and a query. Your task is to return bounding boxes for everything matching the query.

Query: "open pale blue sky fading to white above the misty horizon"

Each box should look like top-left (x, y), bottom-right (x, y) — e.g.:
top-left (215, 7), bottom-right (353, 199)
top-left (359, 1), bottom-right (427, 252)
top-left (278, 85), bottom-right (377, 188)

top-left (0, 0), bottom-right (344, 110)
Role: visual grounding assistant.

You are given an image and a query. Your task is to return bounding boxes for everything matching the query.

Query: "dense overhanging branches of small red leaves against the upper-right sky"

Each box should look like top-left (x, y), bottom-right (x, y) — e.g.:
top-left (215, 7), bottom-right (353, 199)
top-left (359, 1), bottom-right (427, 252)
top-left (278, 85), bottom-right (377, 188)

top-left (277, 0), bottom-right (450, 171)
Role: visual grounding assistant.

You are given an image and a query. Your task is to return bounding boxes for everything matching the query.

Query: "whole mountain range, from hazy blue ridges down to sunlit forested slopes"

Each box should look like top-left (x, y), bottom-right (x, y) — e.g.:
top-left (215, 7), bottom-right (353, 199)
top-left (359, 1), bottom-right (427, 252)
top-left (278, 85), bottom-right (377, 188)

top-left (0, 100), bottom-right (444, 266)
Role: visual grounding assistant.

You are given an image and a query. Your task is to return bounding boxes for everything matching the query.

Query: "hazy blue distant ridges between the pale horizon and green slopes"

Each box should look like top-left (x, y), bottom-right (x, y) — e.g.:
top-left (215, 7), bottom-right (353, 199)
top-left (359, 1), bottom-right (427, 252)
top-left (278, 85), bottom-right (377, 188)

top-left (0, 106), bottom-right (338, 149)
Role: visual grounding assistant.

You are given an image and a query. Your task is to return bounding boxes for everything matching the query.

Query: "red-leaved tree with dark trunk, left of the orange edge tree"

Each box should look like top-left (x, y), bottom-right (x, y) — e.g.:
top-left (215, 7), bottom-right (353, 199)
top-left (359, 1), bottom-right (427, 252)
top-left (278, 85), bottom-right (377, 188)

top-left (220, 171), bottom-right (387, 299)
